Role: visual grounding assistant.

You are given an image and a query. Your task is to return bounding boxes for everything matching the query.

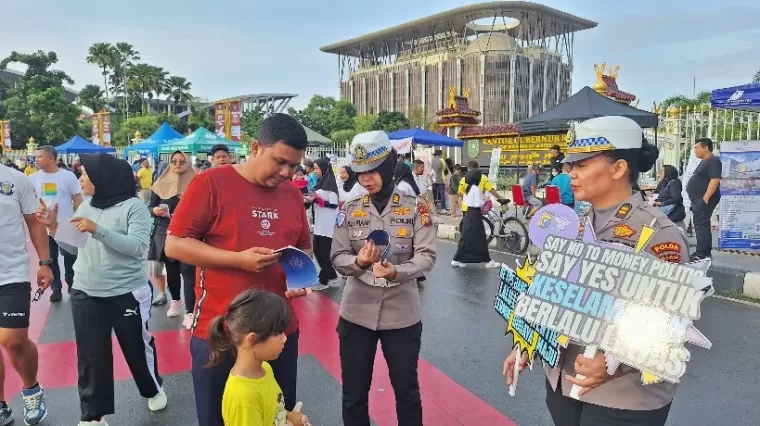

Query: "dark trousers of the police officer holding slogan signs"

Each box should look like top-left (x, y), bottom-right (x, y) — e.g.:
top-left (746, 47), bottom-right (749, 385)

top-left (546, 380), bottom-right (672, 426)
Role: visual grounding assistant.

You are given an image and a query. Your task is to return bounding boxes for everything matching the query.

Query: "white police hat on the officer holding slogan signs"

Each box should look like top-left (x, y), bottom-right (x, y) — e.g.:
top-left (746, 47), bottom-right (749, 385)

top-left (562, 116), bottom-right (644, 163)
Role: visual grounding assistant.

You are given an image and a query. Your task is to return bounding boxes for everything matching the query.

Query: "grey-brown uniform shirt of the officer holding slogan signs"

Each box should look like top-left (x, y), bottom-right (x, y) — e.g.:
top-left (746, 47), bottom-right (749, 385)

top-left (544, 192), bottom-right (690, 410)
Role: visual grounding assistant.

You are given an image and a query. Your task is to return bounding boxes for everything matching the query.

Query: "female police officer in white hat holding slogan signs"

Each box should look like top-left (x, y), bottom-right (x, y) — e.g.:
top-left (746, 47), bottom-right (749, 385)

top-left (504, 117), bottom-right (689, 426)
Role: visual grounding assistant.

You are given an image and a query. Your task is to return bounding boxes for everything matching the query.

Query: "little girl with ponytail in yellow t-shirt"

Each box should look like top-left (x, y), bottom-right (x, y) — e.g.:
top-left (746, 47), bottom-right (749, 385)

top-left (209, 290), bottom-right (308, 426)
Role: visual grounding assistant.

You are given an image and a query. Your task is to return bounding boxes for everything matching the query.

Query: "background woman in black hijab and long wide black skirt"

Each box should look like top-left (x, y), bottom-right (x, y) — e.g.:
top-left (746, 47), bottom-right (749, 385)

top-left (451, 169), bottom-right (491, 267)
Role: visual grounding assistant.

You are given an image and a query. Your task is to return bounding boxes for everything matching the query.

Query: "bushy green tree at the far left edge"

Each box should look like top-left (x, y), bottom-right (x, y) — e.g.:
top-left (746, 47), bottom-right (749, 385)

top-left (0, 50), bottom-right (79, 148)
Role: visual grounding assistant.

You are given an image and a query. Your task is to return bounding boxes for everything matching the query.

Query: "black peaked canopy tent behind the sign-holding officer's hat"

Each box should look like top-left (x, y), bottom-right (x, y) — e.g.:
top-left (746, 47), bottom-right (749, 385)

top-left (518, 86), bottom-right (658, 133)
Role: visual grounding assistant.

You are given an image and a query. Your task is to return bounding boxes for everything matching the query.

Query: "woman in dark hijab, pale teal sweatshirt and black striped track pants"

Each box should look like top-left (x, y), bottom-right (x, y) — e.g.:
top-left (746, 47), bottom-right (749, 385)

top-left (38, 154), bottom-right (167, 424)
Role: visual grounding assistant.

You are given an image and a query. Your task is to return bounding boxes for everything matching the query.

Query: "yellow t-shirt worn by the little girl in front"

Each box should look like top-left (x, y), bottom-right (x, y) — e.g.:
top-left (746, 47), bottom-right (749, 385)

top-left (222, 362), bottom-right (288, 426)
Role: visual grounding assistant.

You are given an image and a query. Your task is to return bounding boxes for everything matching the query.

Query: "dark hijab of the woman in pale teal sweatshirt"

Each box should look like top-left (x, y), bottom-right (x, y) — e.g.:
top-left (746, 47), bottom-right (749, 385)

top-left (81, 153), bottom-right (137, 209)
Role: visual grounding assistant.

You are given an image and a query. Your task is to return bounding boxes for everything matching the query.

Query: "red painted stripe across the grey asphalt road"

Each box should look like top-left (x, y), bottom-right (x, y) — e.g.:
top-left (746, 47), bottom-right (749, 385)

top-left (16, 244), bottom-right (517, 426)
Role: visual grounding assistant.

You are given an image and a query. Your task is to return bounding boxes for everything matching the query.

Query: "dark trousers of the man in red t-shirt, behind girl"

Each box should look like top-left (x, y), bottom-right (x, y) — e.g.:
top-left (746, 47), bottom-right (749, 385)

top-left (190, 330), bottom-right (299, 426)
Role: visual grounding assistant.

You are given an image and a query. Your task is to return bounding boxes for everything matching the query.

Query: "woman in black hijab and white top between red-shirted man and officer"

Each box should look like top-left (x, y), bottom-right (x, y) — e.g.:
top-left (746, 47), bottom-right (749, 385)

top-left (312, 158), bottom-right (339, 290)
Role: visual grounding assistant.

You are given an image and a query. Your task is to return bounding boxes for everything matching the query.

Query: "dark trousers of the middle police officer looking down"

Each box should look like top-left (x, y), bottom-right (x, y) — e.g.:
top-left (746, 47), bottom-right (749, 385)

top-left (337, 318), bottom-right (422, 426)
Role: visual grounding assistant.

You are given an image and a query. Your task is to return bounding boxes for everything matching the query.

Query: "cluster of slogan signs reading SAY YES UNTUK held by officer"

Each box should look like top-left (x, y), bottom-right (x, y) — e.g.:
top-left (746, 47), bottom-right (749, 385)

top-left (497, 204), bottom-right (713, 396)
